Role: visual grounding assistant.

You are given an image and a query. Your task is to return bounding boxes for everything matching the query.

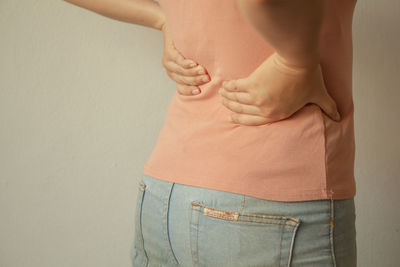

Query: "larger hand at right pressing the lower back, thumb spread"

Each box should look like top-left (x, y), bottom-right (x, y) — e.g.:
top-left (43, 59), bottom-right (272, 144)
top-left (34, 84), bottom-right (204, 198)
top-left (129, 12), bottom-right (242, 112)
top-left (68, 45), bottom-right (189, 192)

top-left (219, 53), bottom-right (340, 126)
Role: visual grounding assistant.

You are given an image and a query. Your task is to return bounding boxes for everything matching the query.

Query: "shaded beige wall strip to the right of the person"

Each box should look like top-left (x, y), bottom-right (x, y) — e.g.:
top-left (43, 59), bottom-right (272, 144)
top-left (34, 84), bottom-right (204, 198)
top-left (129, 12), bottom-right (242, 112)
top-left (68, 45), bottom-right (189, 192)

top-left (353, 0), bottom-right (400, 267)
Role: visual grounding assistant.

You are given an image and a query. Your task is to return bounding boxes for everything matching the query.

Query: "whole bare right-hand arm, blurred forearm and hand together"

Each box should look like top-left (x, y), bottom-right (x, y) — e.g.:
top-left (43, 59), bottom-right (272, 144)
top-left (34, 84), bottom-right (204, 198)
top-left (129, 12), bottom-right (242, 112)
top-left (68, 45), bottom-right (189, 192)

top-left (219, 0), bottom-right (340, 125)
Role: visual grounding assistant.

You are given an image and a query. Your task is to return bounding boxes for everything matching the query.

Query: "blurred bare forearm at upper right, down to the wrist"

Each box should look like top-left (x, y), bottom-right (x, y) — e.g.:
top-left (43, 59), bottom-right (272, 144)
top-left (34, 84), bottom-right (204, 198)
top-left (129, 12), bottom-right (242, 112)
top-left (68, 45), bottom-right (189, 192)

top-left (237, 0), bottom-right (326, 67)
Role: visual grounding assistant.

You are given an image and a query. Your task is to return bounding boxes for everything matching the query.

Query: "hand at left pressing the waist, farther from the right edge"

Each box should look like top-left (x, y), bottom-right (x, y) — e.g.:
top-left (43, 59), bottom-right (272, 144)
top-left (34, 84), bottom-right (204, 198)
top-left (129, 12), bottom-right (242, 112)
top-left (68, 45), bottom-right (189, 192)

top-left (161, 23), bottom-right (210, 95)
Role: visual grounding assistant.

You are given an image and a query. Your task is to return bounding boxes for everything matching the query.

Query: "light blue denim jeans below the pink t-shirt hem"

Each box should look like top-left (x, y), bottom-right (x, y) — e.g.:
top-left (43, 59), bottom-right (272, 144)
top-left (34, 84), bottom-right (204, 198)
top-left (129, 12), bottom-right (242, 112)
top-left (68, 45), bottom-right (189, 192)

top-left (130, 174), bottom-right (357, 267)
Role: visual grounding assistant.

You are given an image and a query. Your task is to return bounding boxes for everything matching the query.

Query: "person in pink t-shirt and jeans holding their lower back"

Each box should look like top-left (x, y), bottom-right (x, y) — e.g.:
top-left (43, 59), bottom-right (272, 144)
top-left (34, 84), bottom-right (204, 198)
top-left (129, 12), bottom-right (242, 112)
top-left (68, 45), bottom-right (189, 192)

top-left (64, 0), bottom-right (357, 267)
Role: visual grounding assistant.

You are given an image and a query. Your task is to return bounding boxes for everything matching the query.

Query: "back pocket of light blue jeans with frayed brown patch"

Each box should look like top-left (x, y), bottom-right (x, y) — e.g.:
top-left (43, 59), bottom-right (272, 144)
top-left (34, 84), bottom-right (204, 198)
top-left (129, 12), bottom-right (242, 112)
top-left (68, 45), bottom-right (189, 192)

top-left (190, 201), bottom-right (301, 267)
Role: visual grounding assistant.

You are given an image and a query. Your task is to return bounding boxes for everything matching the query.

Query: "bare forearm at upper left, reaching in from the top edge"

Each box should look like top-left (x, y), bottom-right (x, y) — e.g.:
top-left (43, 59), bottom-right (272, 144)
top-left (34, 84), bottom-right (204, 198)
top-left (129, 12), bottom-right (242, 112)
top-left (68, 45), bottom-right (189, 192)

top-left (64, 0), bottom-right (165, 29)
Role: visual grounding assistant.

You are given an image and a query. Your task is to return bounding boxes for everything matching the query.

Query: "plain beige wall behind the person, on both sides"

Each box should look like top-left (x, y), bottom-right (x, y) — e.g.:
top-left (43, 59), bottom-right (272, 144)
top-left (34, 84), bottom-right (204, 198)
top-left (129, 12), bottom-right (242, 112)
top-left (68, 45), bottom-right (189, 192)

top-left (0, 0), bottom-right (400, 267)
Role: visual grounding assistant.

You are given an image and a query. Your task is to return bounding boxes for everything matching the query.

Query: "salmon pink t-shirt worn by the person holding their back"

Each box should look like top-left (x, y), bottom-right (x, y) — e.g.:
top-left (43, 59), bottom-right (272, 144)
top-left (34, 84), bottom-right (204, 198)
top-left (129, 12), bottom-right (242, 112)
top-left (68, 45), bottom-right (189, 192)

top-left (143, 0), bottom-right (356, 201)
